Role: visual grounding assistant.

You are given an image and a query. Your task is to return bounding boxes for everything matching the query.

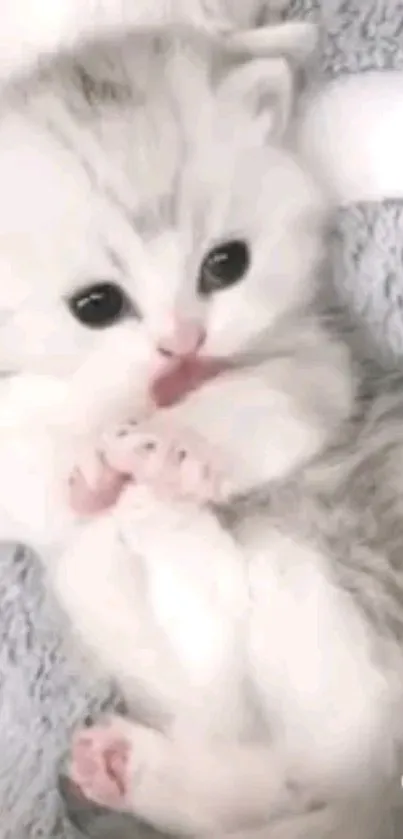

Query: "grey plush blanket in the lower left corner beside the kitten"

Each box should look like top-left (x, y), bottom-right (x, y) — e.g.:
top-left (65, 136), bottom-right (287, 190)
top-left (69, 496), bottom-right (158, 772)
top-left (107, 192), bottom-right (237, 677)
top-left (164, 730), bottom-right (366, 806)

top-left (0, 547), bottom-right (115, 839)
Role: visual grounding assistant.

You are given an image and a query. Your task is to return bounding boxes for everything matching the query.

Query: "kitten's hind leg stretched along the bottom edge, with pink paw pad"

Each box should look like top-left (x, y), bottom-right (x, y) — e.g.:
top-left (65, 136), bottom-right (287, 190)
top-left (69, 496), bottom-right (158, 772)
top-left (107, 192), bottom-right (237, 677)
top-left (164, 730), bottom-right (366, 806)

top-left (70, 704), bottom-right (394, 839)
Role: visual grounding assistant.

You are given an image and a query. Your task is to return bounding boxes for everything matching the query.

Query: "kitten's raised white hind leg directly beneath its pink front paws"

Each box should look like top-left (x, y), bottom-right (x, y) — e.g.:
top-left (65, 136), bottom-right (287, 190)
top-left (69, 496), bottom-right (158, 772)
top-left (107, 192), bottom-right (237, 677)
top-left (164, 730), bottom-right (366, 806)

top-left (53, 470), bottom-right (247, 730)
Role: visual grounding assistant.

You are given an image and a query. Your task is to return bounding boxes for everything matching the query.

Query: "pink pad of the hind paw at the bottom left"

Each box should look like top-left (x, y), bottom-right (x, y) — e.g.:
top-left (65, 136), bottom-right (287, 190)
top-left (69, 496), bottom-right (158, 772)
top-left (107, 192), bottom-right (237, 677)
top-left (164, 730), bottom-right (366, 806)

top-left (69, 725), bottom-right (130, 809)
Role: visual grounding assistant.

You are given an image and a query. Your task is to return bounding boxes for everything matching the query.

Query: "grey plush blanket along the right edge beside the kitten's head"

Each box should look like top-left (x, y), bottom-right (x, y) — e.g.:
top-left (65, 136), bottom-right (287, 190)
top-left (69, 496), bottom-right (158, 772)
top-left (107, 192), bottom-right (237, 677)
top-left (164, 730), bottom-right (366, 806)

top-left (287, 0), bottom-right (403, 357)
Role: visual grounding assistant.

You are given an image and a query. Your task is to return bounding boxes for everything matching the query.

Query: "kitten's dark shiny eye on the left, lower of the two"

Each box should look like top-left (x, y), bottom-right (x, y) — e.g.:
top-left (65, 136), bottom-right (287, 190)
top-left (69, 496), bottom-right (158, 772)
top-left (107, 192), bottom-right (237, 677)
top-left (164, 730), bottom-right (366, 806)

top-left (68, 283), bottom-right (132, 329)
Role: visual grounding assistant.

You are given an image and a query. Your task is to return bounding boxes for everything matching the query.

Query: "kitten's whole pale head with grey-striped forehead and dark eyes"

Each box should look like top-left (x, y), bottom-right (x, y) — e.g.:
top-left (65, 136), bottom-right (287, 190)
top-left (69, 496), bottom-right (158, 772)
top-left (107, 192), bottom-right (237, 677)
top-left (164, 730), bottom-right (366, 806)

top-left (0, 29), bottom-right (325, 414)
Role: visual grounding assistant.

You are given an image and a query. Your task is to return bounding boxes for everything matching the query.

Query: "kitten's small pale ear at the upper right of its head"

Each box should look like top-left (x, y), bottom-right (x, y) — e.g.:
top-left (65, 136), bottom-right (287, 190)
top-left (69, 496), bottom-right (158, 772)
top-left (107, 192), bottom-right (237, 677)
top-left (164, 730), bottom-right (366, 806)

top-left (218, 57), bottom-right (294, 138)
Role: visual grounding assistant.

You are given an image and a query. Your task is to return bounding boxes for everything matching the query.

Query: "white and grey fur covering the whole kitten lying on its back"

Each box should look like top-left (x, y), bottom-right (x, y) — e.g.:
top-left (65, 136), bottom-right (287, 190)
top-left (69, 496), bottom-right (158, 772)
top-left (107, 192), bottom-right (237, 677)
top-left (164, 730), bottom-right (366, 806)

top-left (0, 23), bottom-right (403, 839)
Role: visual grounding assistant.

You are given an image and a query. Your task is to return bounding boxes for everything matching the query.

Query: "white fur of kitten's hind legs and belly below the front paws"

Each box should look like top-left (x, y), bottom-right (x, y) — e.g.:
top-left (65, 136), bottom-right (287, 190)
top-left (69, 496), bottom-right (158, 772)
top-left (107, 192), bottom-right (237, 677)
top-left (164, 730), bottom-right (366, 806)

top-left (55, 488), bottom-right (395, 839)
